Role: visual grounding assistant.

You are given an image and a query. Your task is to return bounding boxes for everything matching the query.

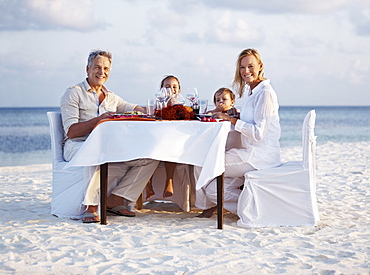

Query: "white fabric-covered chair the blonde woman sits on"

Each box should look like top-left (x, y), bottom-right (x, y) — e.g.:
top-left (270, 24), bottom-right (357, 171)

top-left (237, 110), bottom-right (320, 228)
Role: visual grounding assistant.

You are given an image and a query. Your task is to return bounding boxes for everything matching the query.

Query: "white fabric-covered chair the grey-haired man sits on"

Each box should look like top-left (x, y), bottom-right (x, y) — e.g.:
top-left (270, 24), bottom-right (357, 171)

top-left (47, 112), bottom-right (84, 219)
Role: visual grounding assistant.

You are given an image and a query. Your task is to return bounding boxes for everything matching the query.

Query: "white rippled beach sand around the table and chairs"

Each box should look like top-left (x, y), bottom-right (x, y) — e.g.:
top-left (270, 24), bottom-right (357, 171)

top-left (0, 142), bottom-right (370, 274)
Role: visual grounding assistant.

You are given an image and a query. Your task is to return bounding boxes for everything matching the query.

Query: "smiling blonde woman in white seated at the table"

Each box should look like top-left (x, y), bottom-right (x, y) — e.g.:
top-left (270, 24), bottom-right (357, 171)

top-left (196, 49), bottom-right (281, 218)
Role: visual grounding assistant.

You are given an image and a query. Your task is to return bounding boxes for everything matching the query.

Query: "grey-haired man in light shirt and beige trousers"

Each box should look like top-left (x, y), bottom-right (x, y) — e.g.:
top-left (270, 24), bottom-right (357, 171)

top-left (60, 50), bottom-right (158, 223)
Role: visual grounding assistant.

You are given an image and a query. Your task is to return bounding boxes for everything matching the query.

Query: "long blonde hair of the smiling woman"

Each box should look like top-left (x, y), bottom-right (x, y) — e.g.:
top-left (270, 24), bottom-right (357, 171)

top-left (232, 49), bottom-right (266, 98)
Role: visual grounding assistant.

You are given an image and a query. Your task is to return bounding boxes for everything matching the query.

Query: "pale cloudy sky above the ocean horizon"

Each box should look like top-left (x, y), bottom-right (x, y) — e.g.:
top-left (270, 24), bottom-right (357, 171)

top-left (0, 0), bottom-right (370, 107)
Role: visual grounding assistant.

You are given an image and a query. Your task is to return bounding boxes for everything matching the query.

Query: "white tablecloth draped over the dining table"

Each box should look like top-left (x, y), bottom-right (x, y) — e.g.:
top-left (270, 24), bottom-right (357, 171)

top-left (67, 121), bottom-right (231, 189)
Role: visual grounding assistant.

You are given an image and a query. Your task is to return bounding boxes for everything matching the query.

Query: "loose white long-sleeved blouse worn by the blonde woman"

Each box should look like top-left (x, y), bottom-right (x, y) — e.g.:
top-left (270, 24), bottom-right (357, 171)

top-left (232, 80), bottom-right (281, 169)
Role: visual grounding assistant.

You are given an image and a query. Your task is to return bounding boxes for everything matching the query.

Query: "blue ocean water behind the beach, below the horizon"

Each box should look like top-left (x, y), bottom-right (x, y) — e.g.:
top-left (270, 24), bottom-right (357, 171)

top-left (0, 106), bottom-right (370, 166)
